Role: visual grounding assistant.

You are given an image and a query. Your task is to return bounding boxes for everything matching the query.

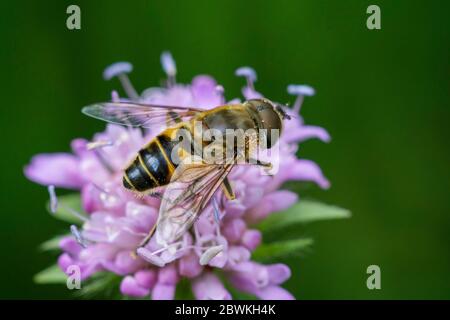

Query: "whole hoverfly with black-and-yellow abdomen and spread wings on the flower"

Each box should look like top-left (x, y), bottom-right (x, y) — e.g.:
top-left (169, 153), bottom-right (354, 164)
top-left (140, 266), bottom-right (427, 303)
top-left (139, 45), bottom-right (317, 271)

top-left (82, 99), bottom-right (289, 246)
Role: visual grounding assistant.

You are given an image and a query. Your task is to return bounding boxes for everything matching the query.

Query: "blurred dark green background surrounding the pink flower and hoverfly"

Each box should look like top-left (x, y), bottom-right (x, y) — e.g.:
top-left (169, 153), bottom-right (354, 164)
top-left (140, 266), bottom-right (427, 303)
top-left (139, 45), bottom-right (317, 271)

top-left (0, 0), bottom-right (450, 299)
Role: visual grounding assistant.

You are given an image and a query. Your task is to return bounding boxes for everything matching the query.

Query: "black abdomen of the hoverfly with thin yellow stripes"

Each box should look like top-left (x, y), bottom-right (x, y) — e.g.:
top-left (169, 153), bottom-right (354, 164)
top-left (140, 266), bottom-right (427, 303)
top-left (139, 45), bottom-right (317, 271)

top-left (123, 133), bottom-right (177, 192)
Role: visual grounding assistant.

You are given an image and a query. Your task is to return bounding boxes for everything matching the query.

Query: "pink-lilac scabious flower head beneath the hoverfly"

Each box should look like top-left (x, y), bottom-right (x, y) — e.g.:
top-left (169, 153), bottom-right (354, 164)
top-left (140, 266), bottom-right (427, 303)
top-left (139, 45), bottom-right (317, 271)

top-left (25, 53), bottom-right (330, 300)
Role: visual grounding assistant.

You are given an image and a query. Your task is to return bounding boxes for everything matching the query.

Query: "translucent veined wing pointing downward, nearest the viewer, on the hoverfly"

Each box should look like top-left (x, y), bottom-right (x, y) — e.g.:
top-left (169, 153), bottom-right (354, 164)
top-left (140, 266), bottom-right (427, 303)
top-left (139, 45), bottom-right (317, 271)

top-left (156, 157), bottom-right (234, 246)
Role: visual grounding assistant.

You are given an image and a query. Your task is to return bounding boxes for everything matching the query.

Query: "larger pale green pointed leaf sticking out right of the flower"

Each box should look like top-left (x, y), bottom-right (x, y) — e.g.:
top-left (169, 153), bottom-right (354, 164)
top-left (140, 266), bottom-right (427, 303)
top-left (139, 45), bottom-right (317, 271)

top-left (258, 200), bottom-right (351, 232)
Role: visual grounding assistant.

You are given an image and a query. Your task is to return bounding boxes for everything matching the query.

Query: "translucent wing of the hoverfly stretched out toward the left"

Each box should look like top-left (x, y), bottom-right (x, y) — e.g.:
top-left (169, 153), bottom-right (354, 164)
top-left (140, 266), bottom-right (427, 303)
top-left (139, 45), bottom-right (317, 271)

top-left (82, 102), bottom-right (204, 128)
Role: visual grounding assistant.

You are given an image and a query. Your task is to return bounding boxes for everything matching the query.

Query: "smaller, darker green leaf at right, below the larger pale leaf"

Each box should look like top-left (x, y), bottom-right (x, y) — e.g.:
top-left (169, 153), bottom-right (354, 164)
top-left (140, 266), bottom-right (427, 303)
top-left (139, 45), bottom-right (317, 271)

top-left (252, 238), bottom-right (313, 261)
